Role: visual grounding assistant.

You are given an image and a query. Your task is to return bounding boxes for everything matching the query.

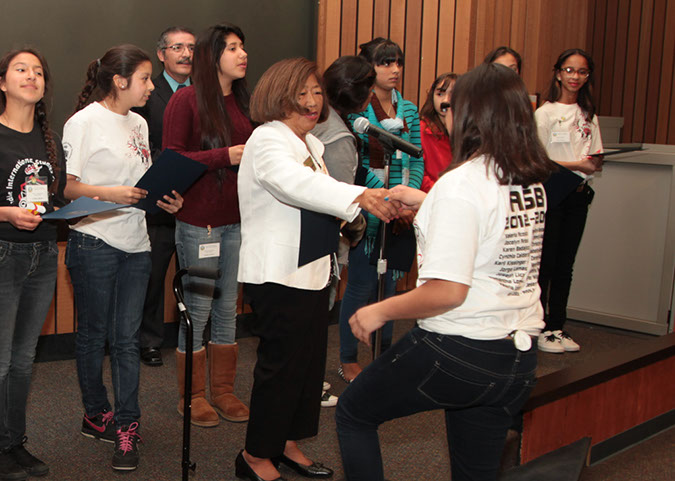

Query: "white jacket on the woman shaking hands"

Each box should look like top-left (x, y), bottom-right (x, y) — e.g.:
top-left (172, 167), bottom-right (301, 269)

top-left (237, 121), bottom-right (365, 290)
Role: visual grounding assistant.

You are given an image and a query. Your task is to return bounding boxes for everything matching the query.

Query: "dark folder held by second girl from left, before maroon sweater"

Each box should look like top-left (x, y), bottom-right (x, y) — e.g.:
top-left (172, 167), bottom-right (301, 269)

top-left (134, 149), bottom-right (207, 214)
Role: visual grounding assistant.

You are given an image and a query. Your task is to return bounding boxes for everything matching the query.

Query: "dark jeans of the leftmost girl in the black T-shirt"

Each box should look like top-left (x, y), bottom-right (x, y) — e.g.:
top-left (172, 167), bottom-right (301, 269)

top-left (0, 241), bottom-right (58, 450)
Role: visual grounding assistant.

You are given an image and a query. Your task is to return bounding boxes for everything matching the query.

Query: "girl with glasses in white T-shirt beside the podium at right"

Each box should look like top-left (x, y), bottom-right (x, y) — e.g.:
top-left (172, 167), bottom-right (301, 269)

top-left (534, 49), bottom-right (602, 353)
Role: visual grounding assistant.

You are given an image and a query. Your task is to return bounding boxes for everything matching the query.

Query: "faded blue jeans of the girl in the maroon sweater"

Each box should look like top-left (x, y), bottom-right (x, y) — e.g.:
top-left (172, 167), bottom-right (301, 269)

top-left (176, 220), bottom-right (241, 351)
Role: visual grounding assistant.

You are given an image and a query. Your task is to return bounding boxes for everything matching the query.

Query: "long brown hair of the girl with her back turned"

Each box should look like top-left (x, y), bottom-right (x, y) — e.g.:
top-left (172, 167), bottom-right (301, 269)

top-left (448, 64), bottom-right (556, 186)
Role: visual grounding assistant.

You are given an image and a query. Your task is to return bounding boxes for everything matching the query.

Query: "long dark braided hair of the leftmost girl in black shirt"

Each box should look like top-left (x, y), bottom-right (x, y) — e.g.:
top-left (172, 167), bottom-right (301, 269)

top-left (0, 48), bottom-right (60, 193)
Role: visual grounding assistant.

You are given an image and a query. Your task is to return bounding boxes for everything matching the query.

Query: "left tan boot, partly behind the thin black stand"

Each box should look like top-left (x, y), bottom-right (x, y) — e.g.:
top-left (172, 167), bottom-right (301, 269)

top-left (176, 347), bottom-right (220, 428)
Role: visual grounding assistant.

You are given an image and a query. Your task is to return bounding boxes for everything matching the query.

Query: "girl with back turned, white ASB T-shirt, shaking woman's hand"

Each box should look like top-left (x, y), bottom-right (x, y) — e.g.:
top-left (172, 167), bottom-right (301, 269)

top-left (336, 64), bottom-right (555, 481)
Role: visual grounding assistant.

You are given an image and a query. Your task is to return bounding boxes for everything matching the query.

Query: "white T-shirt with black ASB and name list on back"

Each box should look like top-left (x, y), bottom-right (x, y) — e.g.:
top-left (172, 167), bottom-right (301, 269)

top-left (414, 156), bottom-right (546, 340)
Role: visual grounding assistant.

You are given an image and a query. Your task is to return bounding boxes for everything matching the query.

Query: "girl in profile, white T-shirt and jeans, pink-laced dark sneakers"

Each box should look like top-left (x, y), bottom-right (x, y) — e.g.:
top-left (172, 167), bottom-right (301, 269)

top-left (63, 45), bottom-right (182, 470)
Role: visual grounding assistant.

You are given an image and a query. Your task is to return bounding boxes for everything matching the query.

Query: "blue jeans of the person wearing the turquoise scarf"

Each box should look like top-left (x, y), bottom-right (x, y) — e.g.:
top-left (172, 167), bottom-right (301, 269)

top-left (340, 238), bottom-right (396, 364)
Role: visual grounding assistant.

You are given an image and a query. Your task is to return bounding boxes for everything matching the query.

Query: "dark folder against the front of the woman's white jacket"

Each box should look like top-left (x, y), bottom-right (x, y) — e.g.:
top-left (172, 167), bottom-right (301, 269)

top-left (298, 209), bottom-right (340, 268)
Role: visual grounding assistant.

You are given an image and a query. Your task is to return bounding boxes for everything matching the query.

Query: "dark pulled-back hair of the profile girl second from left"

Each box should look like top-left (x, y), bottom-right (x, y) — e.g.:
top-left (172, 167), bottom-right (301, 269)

top-left (75, 44), bottom-right (150, 112)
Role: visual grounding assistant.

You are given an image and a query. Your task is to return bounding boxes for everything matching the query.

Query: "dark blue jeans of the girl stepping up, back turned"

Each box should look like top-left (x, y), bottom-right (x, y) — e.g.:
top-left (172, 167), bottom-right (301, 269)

top-left (335, 327), bottom-right (537, 481)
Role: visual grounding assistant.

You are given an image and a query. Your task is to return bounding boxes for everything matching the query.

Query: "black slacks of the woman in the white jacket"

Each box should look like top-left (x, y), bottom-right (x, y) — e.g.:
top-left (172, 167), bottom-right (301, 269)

top-left (244, 283), bottom-right (329, 458)
